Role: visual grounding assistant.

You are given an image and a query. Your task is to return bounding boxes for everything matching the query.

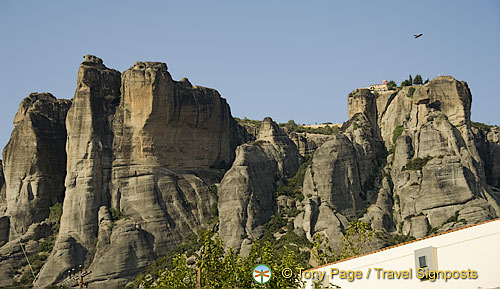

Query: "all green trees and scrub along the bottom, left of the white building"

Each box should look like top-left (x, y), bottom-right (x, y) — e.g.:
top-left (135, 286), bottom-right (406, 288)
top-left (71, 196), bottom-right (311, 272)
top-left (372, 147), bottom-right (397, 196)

top-left (126, 221), bottom-right (374, 289)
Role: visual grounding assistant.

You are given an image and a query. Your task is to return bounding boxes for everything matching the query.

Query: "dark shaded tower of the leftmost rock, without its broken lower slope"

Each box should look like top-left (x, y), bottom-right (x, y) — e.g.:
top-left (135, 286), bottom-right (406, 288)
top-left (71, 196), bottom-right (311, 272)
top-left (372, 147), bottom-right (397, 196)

top-left (2, 93), bottom-right (71, 239)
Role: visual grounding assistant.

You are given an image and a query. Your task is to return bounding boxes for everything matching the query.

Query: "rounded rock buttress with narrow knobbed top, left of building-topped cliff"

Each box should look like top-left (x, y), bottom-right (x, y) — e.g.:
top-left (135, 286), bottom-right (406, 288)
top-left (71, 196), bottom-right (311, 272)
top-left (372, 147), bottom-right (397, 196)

top-left (299, 94), bottom-right (390, 250)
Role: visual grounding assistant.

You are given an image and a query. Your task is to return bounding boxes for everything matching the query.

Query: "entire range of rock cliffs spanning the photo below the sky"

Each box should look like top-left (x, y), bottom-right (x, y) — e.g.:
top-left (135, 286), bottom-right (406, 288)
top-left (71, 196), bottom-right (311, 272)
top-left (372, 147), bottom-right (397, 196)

top-left (0, 55), bottom-right (500, 288)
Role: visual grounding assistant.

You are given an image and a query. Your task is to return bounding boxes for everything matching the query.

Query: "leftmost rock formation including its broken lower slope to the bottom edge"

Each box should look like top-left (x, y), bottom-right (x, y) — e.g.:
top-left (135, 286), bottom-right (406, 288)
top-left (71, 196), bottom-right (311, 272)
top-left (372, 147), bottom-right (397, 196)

top-left (0, 93), bottom-right (71, 286)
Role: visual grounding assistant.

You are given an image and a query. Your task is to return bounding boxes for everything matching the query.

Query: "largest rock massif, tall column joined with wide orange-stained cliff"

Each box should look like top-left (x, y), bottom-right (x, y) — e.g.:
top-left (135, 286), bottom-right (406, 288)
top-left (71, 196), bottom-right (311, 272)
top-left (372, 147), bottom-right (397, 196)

top-left (38, 56), bottom-right (238, 288)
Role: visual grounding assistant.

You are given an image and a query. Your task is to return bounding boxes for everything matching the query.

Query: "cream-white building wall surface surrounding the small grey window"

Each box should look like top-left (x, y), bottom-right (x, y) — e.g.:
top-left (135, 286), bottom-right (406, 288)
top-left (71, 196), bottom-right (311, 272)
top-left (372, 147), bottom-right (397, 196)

top-left (302, 219), bottom-right (500, 289)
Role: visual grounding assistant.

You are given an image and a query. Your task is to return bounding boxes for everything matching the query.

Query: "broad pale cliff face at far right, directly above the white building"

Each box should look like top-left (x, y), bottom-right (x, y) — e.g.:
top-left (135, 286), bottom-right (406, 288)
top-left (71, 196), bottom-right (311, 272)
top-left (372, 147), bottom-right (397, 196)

top-left (380, 77), bottom-right (499, 237)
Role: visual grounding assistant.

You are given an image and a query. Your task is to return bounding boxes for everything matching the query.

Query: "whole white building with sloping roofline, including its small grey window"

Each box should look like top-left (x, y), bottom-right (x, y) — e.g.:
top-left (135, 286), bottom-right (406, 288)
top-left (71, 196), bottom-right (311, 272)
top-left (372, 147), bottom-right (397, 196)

top-left (302, 219), bottom-right (500, 289)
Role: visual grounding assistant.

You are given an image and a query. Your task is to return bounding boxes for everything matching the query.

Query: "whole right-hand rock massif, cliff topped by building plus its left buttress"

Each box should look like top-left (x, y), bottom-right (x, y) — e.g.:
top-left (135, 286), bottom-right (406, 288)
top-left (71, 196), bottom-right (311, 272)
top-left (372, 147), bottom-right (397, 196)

top-left (299, 76), bottom-right (500, 247)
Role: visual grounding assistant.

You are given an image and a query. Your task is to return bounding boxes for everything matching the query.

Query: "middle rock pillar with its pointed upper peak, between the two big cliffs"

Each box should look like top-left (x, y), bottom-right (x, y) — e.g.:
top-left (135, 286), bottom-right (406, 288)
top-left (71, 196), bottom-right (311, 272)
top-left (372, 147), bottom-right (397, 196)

top-left (218, 118), bottom-right (302, 254)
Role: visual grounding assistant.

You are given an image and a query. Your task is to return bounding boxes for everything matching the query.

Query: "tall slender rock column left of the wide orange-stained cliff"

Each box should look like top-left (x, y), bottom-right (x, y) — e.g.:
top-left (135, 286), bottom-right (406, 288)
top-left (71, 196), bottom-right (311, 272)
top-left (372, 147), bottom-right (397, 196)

top-left (39, 55), bottom-right (121, 286)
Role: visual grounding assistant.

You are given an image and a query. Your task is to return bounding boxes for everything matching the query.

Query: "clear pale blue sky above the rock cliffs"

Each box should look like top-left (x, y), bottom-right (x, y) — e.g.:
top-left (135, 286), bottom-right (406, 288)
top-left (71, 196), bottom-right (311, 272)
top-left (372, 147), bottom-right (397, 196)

top-left (0, 0), bottom-right (500, 151)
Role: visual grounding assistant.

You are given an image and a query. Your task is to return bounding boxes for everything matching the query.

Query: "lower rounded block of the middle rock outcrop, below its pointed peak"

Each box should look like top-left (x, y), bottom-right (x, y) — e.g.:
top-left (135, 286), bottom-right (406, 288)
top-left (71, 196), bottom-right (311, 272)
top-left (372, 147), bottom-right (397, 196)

top-left (218, 143), bottom-right (279, 251)
